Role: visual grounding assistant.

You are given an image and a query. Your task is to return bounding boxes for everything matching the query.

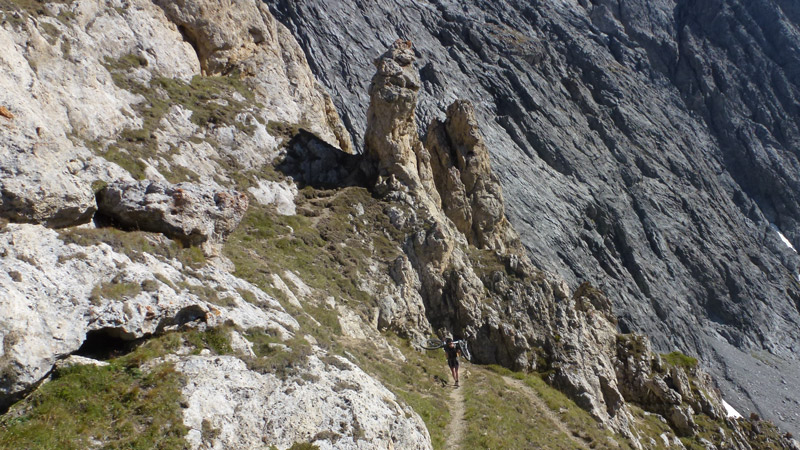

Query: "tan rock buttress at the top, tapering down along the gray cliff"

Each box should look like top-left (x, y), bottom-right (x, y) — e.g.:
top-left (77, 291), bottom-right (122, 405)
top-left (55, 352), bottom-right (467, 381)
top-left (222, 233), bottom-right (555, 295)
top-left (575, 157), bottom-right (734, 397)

top-left (155, 0), bottom-right (352, 152)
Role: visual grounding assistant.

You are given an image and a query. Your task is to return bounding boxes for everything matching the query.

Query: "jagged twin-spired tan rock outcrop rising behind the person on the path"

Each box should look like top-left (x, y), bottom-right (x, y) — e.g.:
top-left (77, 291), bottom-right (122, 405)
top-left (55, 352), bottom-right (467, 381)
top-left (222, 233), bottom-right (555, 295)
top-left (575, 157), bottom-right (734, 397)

top-left (360, 41), bottom-right (631, 433)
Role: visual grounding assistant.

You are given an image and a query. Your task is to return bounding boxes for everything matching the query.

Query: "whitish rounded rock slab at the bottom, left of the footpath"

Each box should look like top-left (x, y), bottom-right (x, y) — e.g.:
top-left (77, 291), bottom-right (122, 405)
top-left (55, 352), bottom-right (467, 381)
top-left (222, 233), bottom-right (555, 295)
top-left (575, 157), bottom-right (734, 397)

top-left (176, 350), bottom-right (432, 450)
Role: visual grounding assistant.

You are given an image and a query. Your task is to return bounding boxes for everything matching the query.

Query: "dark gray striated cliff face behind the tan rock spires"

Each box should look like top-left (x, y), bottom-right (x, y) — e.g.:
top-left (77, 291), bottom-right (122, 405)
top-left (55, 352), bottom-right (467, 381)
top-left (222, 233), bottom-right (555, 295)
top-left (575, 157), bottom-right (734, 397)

top-left (267, 0), bottom-right (800, 432)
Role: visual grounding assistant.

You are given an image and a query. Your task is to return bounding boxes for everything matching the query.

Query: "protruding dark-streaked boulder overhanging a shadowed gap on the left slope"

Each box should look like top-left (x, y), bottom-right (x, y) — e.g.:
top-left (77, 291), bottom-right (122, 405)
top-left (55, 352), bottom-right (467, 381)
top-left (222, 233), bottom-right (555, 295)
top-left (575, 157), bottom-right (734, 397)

top-left (97, 180), bottom-right (249, 245)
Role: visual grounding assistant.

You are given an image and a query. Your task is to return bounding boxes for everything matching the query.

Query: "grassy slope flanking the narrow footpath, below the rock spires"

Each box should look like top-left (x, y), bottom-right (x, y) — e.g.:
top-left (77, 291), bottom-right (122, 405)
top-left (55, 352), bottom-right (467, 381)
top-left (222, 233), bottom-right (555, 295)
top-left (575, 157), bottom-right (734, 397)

top-left (225, 187), bottom-right (648, 448)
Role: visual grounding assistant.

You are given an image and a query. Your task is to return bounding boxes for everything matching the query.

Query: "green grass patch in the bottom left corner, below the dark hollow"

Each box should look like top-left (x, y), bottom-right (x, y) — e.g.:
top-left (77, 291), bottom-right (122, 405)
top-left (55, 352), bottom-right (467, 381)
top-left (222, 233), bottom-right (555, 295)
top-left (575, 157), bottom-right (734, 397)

top-left (0, 335), bottom-right (188, 449)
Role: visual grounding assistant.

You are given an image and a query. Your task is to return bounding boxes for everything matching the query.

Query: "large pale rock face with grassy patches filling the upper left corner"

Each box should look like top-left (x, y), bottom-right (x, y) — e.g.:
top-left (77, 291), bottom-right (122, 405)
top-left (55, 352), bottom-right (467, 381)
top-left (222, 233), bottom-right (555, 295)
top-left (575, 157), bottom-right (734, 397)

top-left (0, 0), bottom-right (351, 236)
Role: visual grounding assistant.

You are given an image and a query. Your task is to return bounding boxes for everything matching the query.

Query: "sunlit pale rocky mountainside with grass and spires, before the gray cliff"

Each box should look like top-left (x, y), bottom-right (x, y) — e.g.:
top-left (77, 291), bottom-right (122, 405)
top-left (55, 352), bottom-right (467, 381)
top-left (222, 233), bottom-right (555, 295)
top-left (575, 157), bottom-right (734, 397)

top-left (0, 0), bottom-right (800, 450)
